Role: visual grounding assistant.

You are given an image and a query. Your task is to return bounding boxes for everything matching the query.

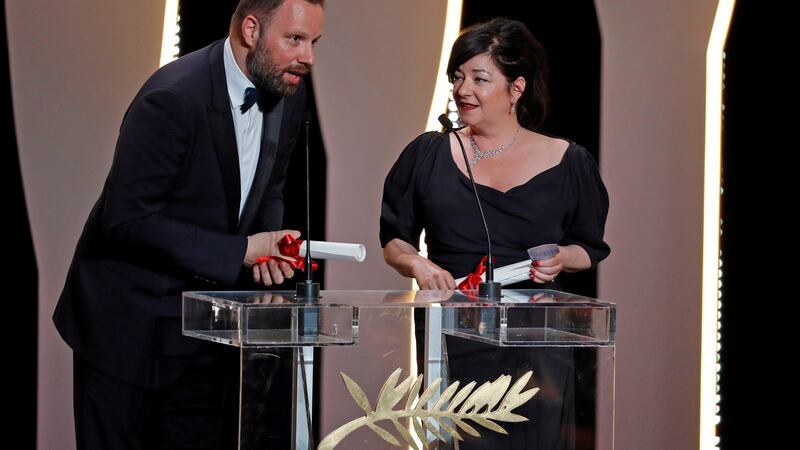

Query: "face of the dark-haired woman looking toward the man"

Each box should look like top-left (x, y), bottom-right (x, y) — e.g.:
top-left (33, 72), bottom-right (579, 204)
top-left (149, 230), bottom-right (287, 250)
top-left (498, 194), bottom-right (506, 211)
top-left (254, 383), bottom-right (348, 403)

top-left (453, 53), bottom-right (516, 126)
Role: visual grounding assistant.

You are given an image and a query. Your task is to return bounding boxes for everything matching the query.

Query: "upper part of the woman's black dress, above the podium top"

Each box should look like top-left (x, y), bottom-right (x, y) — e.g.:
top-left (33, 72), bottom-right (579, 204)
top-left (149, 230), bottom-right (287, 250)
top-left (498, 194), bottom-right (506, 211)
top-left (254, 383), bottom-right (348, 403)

top-left (380, 132), bottom-right (610, 288)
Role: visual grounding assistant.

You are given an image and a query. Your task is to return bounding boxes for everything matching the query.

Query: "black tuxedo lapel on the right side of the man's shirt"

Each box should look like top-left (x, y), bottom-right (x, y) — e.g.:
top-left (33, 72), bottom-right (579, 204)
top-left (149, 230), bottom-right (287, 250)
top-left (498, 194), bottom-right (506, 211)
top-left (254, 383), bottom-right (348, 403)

top-left (239, 99), bottom-right (285, 232)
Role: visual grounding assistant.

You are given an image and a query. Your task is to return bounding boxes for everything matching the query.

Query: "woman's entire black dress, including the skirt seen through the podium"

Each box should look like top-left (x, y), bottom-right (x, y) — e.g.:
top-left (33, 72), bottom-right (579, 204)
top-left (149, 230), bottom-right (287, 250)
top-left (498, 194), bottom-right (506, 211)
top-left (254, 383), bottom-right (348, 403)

top-left (380, 132), bottom-right (610, 450)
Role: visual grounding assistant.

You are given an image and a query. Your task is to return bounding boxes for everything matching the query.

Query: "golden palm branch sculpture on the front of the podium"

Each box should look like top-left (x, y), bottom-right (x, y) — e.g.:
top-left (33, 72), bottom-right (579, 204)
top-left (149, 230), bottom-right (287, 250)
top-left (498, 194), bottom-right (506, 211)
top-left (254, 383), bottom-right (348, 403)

top-left (317, 369), bottom-right (539, 450)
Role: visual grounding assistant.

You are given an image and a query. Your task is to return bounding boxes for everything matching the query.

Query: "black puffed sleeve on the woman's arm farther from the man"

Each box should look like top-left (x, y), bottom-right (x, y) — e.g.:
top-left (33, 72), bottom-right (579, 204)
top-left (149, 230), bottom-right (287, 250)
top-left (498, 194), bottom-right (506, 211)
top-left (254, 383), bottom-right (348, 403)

top-left (563, 147), bottom-right (611, 267)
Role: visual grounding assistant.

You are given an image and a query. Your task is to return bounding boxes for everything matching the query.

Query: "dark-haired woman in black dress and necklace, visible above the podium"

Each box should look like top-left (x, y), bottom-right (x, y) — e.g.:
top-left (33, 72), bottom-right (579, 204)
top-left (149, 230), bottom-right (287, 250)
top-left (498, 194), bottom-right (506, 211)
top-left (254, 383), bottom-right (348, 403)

top-left (380, 19), bottom-right (609, 289)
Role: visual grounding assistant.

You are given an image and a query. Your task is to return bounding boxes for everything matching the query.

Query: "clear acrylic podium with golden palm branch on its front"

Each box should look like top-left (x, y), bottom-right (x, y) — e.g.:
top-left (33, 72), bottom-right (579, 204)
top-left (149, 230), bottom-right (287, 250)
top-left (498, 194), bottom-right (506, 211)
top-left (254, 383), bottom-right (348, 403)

top-left (183, 290), bottom-right (616, 450)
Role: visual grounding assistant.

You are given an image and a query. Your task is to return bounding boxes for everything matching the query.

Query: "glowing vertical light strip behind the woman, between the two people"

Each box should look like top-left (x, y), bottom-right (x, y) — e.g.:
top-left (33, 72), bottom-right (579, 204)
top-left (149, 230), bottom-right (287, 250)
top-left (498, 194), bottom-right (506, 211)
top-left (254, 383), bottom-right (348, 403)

top-left (411, 0), bottom-right (462, 290)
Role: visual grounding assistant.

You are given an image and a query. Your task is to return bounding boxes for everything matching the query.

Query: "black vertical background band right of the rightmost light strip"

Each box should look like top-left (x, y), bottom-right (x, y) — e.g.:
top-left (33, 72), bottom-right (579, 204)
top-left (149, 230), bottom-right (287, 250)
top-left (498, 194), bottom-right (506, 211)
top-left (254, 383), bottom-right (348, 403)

top-left (717, 0), bottom-right (780, 449)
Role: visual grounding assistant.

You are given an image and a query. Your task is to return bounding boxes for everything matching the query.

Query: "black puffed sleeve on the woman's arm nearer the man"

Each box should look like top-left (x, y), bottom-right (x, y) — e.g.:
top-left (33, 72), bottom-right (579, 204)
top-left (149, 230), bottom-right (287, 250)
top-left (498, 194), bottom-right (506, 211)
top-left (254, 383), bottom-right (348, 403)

top-left (380, 132), bottom-right (441, 250)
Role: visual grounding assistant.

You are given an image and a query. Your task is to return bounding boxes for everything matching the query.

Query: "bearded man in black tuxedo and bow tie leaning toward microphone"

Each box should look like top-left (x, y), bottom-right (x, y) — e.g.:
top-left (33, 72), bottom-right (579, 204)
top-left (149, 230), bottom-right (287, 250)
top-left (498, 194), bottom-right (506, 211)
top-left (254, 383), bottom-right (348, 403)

top-left (53, 0), bottom-right (324, 449)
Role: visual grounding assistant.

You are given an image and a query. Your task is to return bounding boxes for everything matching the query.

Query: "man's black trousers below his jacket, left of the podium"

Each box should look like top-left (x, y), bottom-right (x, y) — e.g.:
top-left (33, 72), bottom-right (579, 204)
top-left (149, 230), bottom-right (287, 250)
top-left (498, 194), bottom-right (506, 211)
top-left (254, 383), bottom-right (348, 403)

top-left (73, 353), bottom-right (238, 450)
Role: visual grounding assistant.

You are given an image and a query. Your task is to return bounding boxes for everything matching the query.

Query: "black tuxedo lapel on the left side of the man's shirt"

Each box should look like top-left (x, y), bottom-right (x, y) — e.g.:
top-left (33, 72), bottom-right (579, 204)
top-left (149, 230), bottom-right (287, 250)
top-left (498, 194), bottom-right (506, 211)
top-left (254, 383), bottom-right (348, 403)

top-left (208, 41), bottom-right (242, 233)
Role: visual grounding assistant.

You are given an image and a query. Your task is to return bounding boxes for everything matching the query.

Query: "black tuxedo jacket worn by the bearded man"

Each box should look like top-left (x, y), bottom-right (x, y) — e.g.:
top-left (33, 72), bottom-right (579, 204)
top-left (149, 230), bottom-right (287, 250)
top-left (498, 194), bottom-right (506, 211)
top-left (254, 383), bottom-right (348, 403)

top-left (53, 41), bottom-right (305, 387)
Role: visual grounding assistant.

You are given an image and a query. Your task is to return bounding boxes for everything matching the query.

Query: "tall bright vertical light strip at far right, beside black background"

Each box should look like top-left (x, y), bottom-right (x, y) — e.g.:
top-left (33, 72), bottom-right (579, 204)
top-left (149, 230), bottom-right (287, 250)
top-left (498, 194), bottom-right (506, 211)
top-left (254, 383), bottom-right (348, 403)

top-left (700, 0), bottom-right (734, 450)
